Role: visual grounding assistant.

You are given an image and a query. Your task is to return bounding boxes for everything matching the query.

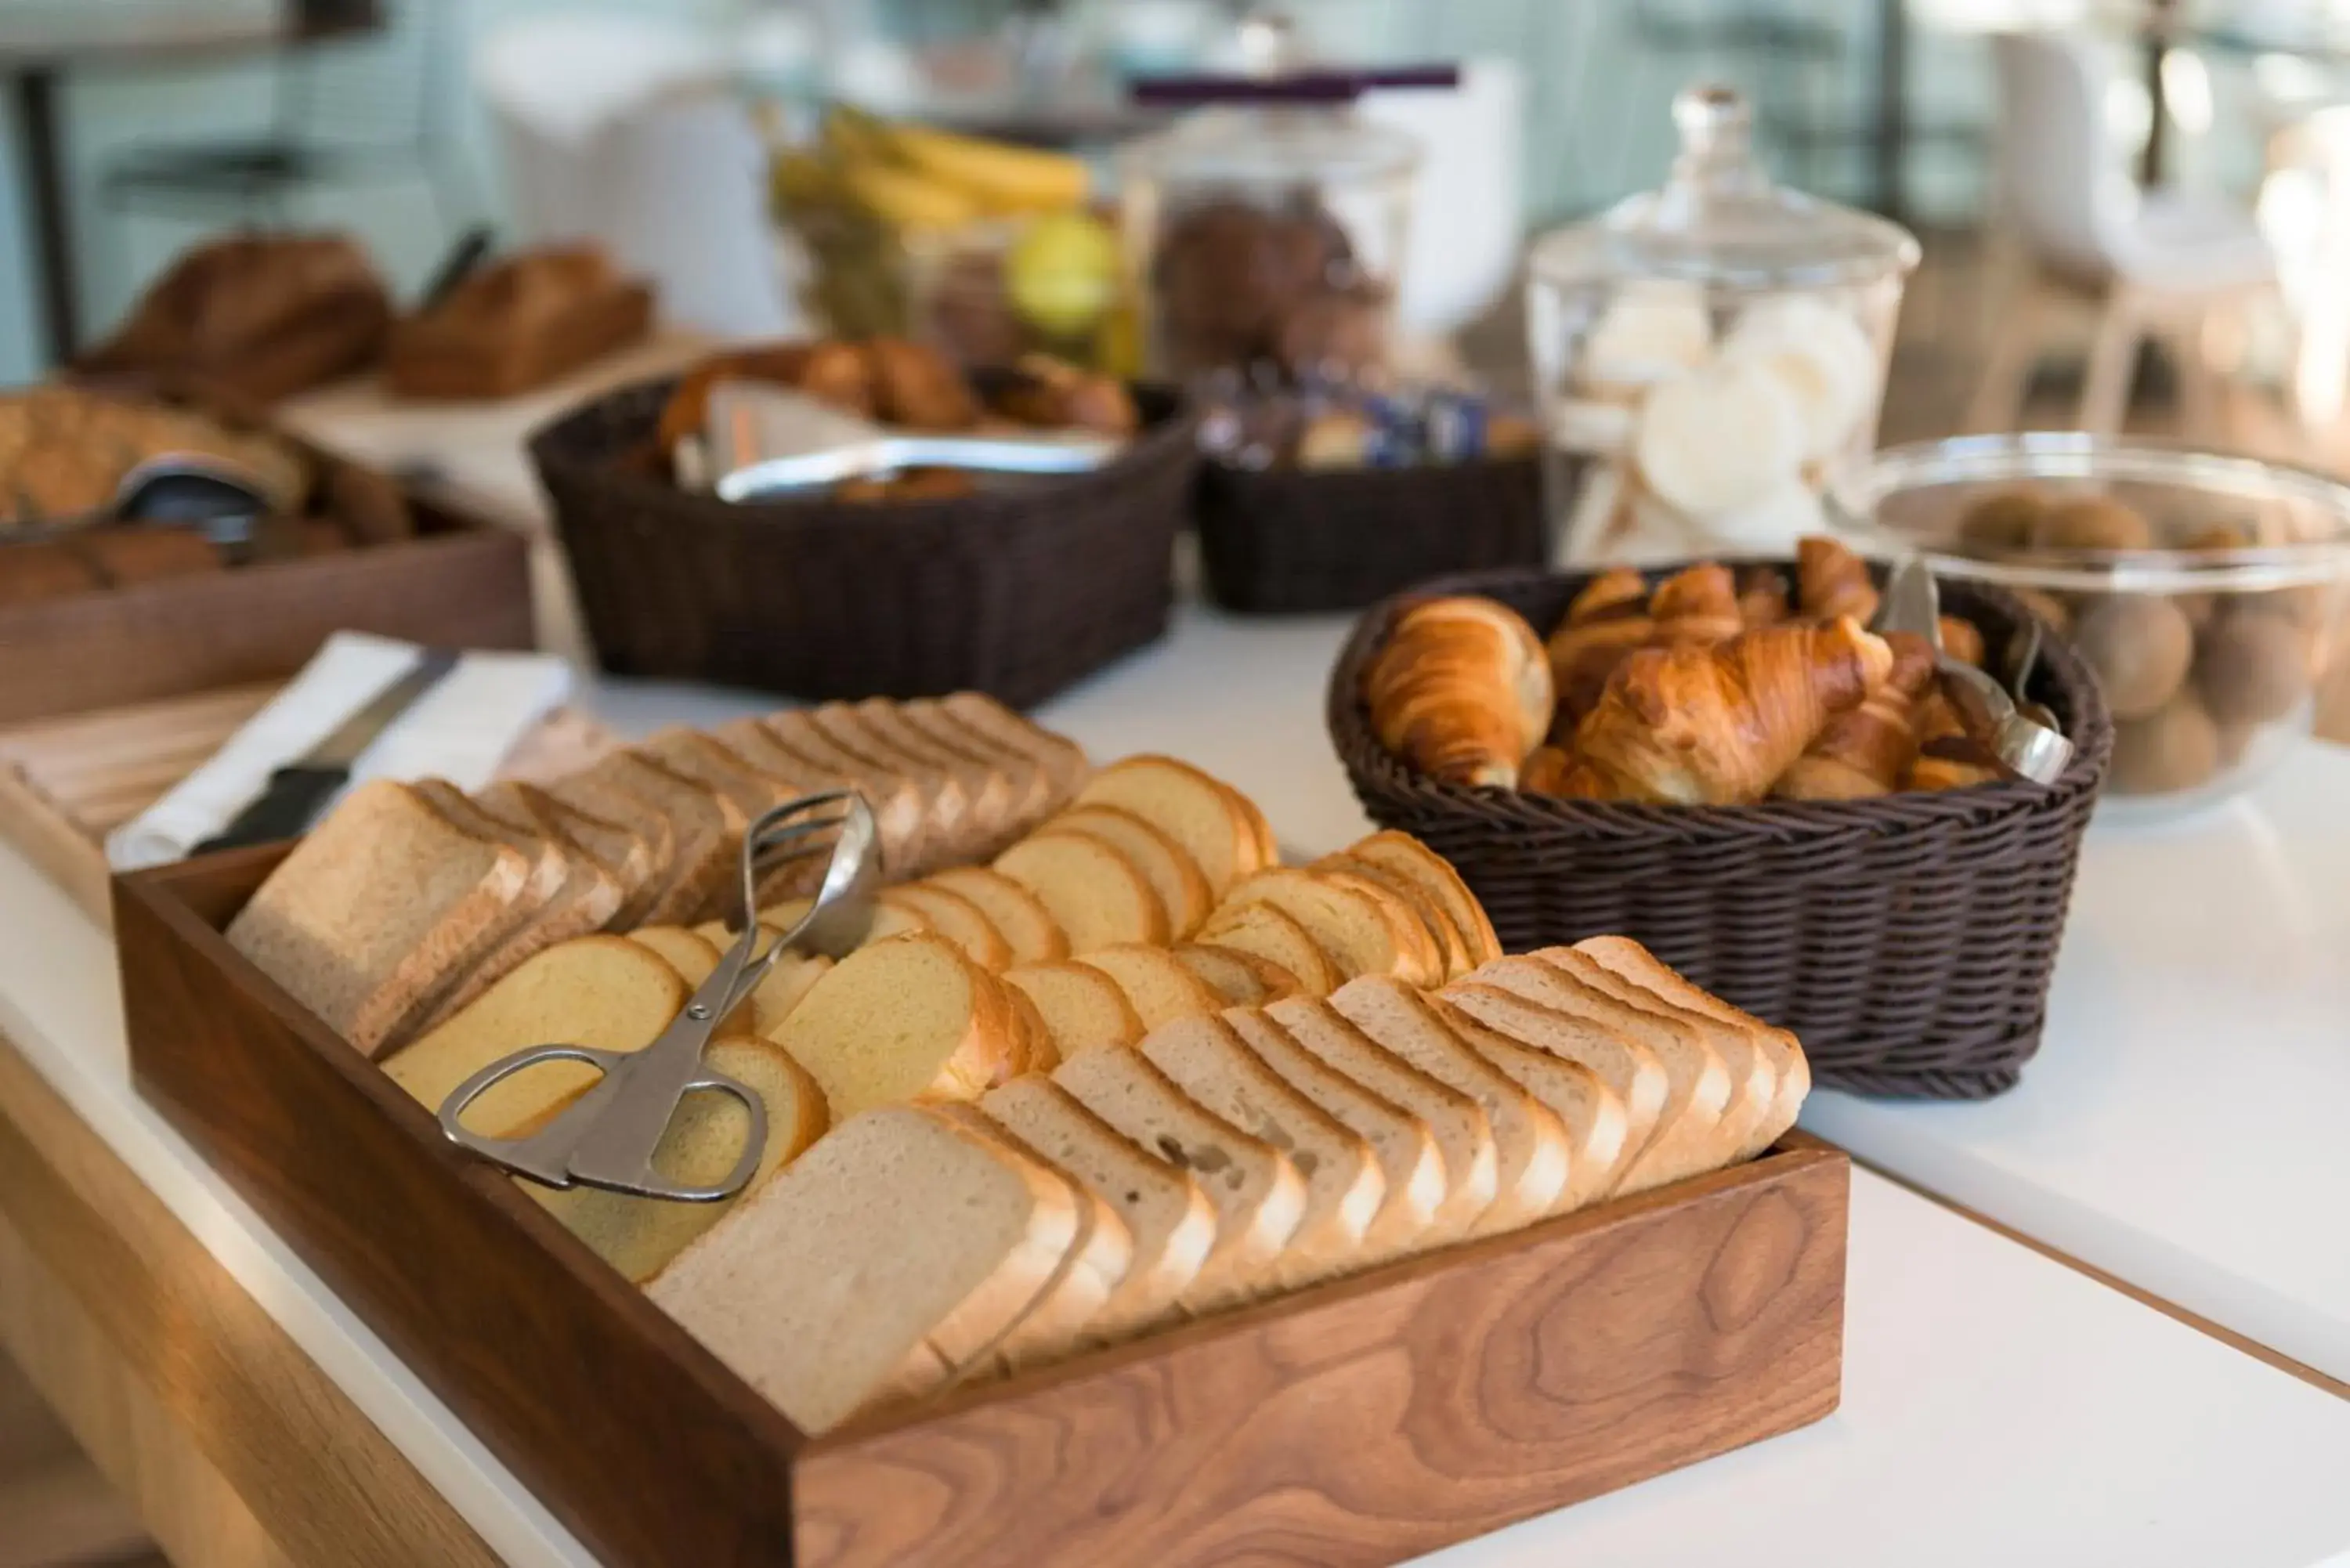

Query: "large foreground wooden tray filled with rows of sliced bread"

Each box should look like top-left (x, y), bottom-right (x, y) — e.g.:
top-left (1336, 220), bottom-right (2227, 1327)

top-left (115, 695), bottom-right (1847, 1568)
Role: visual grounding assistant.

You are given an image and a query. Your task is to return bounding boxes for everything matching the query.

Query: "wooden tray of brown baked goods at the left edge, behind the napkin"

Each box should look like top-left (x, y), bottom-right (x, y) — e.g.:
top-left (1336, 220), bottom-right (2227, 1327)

top-left (0, 383), bottom-right (533, 724)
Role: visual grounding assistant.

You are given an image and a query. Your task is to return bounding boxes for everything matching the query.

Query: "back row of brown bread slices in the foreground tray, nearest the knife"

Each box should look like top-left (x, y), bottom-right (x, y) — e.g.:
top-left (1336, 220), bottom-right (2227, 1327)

top-left (228, 693), bottom-right (1090, 1056)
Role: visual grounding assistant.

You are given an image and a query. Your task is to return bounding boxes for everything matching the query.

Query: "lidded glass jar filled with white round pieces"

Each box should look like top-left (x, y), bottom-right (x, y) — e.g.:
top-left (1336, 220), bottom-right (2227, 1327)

top-left (1525, 87), bottom-right (1918, 562)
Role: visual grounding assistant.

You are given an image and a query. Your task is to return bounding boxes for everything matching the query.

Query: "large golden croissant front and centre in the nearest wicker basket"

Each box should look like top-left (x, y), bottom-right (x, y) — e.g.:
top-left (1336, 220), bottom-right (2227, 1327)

top-left (1558, 616), bottom-right (1894, 807)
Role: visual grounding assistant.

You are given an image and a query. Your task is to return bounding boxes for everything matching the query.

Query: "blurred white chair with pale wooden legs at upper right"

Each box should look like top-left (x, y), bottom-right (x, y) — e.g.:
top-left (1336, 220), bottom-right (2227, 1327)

top-left (1967, 31), bottom-right (2277, 432)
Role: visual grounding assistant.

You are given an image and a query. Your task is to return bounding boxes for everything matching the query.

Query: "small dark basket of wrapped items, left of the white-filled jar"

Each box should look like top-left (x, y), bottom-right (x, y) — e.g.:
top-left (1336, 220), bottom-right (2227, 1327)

top-left (1194, 456), bottom-right (1549, 613)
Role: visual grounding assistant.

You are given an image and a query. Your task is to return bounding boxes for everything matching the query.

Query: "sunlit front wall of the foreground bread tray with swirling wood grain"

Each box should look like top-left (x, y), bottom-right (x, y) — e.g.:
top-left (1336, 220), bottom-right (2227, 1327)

top-left (797, 1147), bottom-right (1849, 1568)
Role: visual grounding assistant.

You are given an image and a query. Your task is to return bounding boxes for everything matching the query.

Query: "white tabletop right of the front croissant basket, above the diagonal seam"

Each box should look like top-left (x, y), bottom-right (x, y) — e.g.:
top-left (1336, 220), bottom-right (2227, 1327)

top-left (1802, 742), bottom-right (2350, 1382)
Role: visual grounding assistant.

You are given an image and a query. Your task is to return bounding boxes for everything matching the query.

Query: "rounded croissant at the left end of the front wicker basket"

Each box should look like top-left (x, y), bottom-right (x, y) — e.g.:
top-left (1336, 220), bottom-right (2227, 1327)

top-left (1363, 597), bottom-right (1553, 788)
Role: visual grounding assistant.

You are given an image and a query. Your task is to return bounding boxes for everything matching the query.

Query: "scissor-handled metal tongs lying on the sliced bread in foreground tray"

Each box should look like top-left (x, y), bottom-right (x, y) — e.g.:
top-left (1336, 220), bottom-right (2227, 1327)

top-left (439, 790), bottom-right (881, 1204)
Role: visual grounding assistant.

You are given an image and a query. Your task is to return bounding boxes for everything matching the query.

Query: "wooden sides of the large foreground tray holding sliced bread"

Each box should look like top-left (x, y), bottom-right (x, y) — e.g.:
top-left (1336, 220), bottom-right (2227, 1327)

top-left (115, 847), bottom-right (1849, 1568)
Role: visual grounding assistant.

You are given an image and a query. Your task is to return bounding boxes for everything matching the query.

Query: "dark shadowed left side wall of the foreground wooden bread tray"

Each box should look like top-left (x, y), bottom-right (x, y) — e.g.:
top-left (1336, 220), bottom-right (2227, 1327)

top-left (115, 847), bottom-right (801, 1568)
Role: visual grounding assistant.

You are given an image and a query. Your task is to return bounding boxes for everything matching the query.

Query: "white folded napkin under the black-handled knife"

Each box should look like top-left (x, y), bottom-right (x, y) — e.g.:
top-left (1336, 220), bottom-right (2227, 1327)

top-left (106, 632), bottom-right (571, 873)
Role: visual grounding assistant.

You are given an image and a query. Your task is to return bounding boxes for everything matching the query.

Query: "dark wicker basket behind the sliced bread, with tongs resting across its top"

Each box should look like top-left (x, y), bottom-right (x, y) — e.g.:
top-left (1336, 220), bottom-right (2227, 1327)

top-left (531, 381), bottom-right (1198, 707)
